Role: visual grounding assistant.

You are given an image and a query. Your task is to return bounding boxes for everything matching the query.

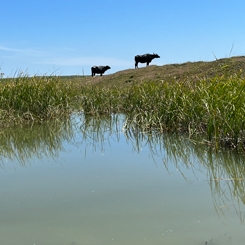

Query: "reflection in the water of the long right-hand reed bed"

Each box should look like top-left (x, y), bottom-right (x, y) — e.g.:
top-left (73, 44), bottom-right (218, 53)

top-left (78, 115), bottom-right (245, 223)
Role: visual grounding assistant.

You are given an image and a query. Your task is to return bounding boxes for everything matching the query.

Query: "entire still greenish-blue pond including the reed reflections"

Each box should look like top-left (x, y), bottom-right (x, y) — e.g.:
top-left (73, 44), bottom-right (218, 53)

top-left (0, 115), bottom-right (245, 245)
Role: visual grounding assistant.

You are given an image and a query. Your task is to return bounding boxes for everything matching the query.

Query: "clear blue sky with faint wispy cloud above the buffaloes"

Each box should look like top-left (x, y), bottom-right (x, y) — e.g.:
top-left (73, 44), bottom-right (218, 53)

top-left (0, 0), bottom-right (245, 77)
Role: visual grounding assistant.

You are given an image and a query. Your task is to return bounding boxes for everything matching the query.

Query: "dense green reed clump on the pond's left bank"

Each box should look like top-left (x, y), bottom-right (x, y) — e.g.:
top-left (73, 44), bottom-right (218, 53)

top-left (0, 76), bottom-right (73, 126)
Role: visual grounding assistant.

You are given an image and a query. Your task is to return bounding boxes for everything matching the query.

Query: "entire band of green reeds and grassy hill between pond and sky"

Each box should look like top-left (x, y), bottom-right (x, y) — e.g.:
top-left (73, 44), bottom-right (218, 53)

top-left (0, 57), bottom-right (245, 150)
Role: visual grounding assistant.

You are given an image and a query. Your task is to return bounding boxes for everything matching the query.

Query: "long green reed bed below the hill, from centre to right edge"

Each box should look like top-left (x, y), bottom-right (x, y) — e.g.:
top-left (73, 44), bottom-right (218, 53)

top-left (77, 75), bottom-right (245, 149)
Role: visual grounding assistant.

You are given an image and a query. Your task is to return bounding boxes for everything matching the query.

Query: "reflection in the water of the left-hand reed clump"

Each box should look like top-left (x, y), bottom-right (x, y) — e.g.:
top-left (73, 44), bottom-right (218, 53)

top-left (0, 119), bottom-right (74, 166)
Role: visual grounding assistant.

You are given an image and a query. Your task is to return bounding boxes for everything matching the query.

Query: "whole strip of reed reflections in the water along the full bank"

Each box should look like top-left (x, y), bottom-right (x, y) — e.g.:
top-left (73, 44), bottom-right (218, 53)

top-left (0, 114), bottom-right (245, 223)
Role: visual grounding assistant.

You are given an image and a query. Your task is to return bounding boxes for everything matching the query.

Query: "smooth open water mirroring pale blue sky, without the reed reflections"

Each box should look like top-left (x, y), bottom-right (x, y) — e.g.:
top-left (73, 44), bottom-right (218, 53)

top-left (0, 115), bottom-right (245, 245)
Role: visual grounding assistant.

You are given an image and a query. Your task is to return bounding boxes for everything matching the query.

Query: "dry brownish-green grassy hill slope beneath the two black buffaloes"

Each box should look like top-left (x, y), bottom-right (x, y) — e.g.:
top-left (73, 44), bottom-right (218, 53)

top-left (63, 56), bottom-right (245, 86)
